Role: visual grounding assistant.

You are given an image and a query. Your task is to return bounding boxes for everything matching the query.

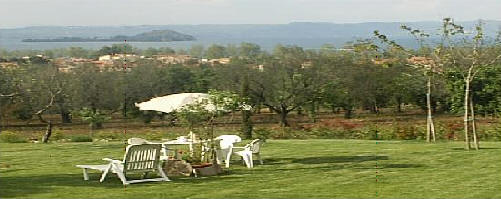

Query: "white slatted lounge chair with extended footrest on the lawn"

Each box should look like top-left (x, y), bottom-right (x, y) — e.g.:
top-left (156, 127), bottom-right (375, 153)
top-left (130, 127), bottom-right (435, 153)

top-left (76, 144), bottom-right (170, 185)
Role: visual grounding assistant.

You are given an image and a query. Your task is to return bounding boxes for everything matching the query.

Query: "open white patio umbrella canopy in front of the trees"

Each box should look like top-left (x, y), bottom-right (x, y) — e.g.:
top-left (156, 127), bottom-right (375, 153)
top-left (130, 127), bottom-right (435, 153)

top-left (135, 93), bottom-right (216, 113)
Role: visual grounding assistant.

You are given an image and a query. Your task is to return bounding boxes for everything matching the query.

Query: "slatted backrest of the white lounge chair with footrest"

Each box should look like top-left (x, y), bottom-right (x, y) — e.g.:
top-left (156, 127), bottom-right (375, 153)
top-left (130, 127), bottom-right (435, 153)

top-left (124, 144), bottom-right (162, 173)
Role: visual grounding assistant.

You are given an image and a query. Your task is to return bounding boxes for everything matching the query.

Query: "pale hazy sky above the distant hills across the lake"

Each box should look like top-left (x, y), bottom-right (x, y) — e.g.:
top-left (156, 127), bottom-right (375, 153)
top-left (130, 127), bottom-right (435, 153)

top-left (0, 0), bottom-right (501, 28)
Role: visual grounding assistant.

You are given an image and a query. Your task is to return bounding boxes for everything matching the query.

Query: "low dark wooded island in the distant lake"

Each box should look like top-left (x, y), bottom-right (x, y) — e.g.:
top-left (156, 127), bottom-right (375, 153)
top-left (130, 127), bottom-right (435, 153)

top-left (22, 30), bottom-right (196, 42)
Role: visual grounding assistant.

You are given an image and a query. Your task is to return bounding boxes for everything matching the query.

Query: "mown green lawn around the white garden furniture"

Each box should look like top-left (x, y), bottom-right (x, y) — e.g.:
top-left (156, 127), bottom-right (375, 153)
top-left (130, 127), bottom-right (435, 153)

top-left (0, 140), bottom-right (501, 198)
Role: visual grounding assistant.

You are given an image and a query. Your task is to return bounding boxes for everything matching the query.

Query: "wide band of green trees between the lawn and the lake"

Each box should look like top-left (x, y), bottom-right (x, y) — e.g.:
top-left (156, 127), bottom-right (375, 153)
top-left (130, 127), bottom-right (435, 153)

top-left (0, 19), bottom-right (501, 149)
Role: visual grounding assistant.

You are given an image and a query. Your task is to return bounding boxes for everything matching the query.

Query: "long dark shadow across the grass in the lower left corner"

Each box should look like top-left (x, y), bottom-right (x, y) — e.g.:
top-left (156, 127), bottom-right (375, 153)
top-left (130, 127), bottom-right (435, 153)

top-left (0, 173), bottom-right (242, 198)
